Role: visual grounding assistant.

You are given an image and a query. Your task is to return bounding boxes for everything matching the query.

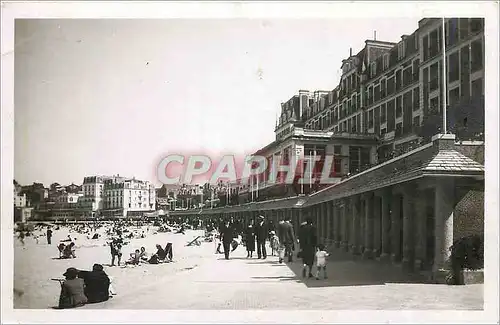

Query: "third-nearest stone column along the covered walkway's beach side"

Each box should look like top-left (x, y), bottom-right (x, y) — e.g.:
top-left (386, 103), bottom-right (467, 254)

top-left (402, 184), bottom-right (418, 270)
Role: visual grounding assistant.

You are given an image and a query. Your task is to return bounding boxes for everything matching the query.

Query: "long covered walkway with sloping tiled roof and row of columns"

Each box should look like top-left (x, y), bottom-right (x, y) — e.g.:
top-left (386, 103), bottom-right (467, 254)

top-left (173, 134), bottom-right (484, 282)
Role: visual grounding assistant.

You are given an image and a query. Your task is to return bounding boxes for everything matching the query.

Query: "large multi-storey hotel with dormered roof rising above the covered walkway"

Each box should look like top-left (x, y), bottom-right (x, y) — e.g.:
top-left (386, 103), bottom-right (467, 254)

top-left (233, 18), bottom-right (484, 204)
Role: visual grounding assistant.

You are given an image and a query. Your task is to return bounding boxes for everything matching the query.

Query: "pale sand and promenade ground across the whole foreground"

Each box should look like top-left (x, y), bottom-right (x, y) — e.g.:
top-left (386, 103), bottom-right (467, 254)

top-left (14, 231), bottom-right (483, 310)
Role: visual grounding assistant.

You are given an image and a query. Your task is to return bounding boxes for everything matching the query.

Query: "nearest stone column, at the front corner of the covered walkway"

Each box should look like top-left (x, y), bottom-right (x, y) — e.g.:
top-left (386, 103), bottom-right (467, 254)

top-left (432, 178), bottom-right (455, 280)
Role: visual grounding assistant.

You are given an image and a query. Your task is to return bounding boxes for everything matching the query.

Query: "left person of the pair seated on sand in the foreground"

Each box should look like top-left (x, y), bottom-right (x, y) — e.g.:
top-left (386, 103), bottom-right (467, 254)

top-left (59, 267), bottom-right (87, 309)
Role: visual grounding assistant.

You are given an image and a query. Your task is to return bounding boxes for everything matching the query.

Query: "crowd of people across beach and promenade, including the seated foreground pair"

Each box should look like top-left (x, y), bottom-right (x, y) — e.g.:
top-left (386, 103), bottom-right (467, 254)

top-left (16, 215), bottom-right (328, 308)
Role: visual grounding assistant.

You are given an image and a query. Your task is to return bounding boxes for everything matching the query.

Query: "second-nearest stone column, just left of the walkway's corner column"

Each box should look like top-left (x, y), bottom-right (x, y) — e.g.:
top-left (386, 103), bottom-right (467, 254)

top-left (415, 195), bottom-right (427, 271)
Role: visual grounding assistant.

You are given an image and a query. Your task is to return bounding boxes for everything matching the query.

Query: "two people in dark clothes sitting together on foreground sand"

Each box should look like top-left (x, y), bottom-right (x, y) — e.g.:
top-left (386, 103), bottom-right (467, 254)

top-left (53, 264), bottom-right (115, 309)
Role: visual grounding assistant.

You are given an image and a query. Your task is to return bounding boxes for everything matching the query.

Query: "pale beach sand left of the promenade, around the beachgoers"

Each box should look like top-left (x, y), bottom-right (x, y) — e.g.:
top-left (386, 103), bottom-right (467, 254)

top-left (14, 227), bottom-right (208, 309)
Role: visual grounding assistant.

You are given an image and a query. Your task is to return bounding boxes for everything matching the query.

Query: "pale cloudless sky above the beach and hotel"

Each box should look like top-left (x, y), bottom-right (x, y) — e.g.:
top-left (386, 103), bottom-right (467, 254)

top-left (14, 18), bottom-right (419, 186)
